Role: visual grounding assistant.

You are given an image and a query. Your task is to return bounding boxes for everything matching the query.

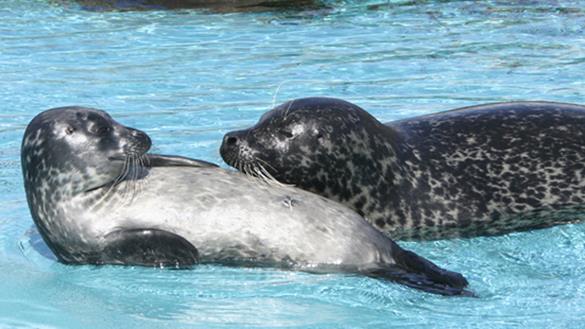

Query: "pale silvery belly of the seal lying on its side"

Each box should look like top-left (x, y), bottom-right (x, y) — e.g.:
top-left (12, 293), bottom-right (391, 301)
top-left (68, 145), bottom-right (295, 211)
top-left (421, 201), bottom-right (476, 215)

top-left (88, 167), bottom-right (389, 266)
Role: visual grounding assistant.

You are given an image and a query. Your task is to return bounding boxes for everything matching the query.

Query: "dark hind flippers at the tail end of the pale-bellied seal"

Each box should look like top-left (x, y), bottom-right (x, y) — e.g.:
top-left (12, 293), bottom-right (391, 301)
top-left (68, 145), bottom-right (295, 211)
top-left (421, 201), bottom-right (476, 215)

top-left (363, 244), bottom-right (474, 296)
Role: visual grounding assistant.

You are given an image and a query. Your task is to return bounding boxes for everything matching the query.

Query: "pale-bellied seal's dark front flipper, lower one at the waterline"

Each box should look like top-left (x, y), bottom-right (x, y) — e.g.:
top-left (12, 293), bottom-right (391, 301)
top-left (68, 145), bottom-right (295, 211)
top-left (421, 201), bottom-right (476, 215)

top-left (100, 229), bottom-right (199, 268)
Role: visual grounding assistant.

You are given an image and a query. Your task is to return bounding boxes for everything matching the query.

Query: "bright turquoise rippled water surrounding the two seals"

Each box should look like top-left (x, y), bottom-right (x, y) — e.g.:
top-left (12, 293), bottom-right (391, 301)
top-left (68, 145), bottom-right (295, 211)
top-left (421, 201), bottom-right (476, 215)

top-left (0, 0), bottom-right (585, 329)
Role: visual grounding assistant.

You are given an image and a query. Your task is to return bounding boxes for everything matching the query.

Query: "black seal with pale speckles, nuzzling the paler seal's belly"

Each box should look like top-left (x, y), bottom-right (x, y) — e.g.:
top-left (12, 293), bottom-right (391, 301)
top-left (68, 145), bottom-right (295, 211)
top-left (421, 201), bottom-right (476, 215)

top-left (221, 98), bottom-right (585, 239)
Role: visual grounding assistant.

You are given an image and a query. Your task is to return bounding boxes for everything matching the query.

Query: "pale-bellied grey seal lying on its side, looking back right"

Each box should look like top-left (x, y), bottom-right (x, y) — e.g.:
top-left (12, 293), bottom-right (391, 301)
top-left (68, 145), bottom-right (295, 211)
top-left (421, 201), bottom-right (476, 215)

top-left (21, 107), bottom-right (470, 295)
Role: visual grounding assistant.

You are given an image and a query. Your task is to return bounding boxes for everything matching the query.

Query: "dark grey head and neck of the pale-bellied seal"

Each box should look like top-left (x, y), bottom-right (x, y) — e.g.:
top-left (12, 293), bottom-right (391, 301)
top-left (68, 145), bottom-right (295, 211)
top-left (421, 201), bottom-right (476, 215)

top-left (21, 107), bottom-right (151, 262)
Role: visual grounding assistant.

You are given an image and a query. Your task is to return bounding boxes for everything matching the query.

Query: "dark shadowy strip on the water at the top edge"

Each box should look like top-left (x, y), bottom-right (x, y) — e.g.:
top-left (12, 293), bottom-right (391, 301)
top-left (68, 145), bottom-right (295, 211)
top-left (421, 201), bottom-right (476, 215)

top-left (51, 0), bottom-right (326, 12)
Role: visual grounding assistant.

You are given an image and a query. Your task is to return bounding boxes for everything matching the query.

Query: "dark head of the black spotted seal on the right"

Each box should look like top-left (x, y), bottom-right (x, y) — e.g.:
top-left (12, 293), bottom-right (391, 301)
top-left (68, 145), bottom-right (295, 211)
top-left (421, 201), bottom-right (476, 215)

top-left (220, 98), bottom-right (391, 200)
